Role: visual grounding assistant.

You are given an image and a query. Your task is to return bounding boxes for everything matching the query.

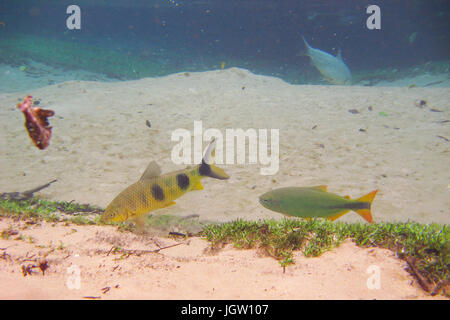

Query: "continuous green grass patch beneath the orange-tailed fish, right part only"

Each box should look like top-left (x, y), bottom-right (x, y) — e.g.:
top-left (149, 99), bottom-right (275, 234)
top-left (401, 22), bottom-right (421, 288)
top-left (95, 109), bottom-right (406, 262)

top-left (203, 219), bottom-right (450, 296)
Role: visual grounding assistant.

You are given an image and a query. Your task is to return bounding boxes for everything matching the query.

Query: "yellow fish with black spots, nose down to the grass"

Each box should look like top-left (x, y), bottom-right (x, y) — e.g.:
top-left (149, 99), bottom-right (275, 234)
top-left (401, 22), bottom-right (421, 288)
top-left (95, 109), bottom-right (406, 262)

top-left (101, 140), bottom-right (229, 222)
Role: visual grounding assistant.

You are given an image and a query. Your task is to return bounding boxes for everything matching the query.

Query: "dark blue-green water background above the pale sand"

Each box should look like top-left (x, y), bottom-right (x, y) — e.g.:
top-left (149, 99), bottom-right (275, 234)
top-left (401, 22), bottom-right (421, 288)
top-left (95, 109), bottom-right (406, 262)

top-left (0, 0), bottom-right (450, 83)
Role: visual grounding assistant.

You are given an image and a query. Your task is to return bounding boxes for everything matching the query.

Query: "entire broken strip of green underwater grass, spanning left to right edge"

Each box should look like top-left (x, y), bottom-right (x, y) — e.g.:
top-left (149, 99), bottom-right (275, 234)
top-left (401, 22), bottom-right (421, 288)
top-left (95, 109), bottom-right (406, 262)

top-left (0, 198), bottom-right (450, 296)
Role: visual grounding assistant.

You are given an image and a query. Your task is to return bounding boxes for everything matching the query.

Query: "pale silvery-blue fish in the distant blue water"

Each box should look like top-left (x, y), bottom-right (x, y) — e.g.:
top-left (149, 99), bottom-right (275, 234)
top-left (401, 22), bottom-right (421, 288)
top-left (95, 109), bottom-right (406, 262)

top-left (302, 37), bottom-right (352, 84)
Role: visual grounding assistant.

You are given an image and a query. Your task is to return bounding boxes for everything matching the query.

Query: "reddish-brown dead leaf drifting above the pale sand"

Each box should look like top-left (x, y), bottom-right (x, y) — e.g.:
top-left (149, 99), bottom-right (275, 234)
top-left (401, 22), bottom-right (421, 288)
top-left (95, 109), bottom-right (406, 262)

top-left (17, 96), bottom-right (55, 150)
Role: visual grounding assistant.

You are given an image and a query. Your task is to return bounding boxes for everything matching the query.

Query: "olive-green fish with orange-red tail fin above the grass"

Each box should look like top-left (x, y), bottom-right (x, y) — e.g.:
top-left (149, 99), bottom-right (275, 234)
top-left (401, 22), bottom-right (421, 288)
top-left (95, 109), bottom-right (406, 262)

top-left (259, 186), bottom-right (378, 222)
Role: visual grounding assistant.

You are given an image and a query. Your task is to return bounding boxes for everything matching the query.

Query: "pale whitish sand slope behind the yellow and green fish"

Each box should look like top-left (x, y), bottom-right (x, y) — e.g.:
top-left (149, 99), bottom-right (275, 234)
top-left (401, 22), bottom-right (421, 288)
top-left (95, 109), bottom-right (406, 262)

top-left (0, 68), bottom-right (450, 223)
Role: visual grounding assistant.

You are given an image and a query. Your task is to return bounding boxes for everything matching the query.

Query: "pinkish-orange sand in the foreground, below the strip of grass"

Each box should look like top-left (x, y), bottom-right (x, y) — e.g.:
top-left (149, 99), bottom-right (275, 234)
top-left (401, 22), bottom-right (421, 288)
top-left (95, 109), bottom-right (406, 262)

top-left (0, 218), bottom-right (443, 299)
